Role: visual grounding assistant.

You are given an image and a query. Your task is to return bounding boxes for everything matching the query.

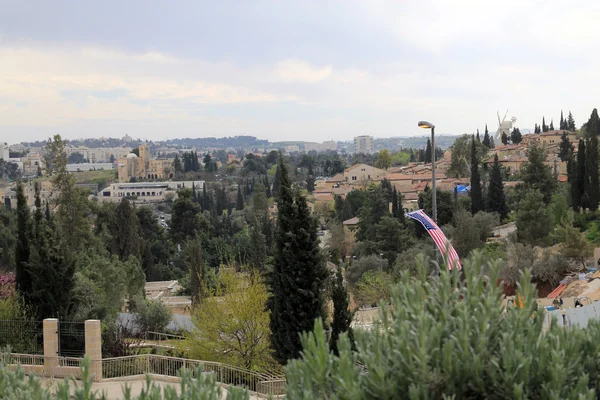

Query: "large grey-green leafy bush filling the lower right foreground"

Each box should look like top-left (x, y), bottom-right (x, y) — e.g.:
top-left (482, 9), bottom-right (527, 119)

top-left (286, 253), bottom-right (600, 400)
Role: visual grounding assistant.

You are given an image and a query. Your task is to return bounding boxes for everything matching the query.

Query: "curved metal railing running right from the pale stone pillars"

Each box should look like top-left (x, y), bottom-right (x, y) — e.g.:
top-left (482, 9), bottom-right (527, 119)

top-left (102, 354), bottom-right (285, 396)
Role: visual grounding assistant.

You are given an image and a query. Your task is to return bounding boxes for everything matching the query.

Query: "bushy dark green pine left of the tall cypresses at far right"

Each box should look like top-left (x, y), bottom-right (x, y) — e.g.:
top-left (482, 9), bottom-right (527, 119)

top-left (521, 142), bottom-right (556, 204)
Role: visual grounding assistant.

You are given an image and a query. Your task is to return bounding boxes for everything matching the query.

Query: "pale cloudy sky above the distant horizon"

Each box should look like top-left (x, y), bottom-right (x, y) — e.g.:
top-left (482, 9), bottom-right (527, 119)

top-left (0, 0), bottom-right (600, 143)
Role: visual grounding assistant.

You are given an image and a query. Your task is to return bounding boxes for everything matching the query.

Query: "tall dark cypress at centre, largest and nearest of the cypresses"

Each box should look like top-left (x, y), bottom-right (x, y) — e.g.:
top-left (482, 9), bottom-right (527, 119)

top-left (269, 156), bottom-right (327, 364)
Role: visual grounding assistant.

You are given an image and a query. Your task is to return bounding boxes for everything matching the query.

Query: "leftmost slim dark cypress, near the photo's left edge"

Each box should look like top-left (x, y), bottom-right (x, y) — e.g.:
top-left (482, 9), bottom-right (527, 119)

top-left (15, 182), bottom-right (32, 301)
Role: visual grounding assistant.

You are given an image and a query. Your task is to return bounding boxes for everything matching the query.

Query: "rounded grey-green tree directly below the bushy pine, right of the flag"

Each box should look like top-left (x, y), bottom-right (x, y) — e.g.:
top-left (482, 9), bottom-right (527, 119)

top-left (516, 191), bottom-right (552, 246)
